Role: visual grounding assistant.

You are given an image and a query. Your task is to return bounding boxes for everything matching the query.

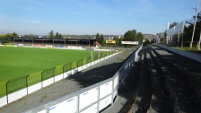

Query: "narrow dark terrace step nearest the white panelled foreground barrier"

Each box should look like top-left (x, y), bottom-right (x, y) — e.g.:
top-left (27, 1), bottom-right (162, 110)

top-left (130, 52), bottom-right (152, 113)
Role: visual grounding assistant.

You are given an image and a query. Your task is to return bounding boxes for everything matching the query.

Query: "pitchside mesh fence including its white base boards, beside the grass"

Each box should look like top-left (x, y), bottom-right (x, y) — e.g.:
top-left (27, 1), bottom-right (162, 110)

top-left (0, 51), bottom-right (118, 107)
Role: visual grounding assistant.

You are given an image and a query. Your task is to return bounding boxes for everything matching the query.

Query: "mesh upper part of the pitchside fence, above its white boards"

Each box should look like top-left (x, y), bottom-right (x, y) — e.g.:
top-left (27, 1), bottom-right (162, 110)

top-left (0, 51), bottom-right (115, 100)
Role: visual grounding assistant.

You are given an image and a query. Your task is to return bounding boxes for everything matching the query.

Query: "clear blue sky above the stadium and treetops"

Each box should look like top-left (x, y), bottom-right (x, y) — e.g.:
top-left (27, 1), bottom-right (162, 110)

top-left (0, 0), bottom-right (197, 35)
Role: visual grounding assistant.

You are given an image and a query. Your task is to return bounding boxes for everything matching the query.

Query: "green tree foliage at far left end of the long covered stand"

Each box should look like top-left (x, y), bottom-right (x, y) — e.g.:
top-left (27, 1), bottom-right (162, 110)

top-left (0, 32), bottom-right (17, 44)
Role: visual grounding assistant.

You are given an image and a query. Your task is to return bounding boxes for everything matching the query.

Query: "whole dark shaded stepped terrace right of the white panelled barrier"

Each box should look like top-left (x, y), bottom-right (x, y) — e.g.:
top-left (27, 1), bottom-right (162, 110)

top-left (130, 45), bottom-right (201, 113)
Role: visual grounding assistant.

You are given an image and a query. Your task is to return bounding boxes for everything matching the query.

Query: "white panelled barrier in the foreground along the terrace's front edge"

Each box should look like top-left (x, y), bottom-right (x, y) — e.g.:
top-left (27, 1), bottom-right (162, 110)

top-left (24, 47), bottom-right (142, 113)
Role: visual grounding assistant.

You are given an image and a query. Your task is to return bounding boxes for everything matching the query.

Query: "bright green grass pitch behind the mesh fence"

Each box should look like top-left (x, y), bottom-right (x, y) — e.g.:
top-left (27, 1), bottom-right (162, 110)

top-left (0, 47), bottom-right (90, 82)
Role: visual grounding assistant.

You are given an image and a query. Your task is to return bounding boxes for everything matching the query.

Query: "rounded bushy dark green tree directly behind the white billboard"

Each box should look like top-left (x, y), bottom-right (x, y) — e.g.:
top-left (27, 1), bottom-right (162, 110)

top-left (123, 29), bottom-right (137, 41)
